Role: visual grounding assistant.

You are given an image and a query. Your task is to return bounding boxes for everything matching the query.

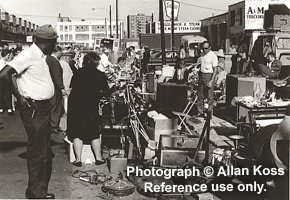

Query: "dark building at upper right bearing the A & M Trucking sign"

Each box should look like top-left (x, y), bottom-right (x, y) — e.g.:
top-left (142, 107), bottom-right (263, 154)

top-left (201, 0), bottom-right (290, 51)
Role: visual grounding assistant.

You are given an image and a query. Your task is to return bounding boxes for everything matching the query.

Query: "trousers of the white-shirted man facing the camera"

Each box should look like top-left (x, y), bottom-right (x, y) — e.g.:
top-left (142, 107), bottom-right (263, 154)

top-left (197, 73), bottom-right (214, 115)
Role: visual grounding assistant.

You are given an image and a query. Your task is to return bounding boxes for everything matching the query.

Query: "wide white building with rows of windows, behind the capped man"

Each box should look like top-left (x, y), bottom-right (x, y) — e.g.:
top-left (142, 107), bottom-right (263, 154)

top-left (56, 18), bottom-right (123, 48)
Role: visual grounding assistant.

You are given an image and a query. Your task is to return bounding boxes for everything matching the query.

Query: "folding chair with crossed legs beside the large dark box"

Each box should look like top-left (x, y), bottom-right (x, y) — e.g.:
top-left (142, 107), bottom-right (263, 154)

top-left (172, 92), bottom-right (197, 135)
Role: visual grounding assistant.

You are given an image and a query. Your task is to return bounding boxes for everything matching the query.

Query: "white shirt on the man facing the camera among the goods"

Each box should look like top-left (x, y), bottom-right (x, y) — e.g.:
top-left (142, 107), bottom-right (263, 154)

top-left (200, 51), bottom-right (218, 73)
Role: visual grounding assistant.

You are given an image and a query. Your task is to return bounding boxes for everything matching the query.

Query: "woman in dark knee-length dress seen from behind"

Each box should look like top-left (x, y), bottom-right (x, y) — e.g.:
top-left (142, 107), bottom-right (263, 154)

top-left (67, 52), bottom-right (111, 167)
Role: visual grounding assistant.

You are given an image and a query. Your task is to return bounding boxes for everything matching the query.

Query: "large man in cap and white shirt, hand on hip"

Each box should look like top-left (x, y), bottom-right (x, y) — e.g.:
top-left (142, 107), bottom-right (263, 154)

top-left (0, 25), bottom-right (58, 199)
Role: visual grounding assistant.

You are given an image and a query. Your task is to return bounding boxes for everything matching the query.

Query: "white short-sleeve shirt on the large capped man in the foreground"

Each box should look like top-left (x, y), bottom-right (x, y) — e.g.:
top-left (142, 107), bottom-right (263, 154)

top-left (8, 43), bottom-right (54, 100)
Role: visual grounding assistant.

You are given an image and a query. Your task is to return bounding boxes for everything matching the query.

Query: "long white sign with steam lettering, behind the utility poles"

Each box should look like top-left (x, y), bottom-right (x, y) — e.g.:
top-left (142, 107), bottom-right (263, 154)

top-left (155, 21), bottom-right (201, 33)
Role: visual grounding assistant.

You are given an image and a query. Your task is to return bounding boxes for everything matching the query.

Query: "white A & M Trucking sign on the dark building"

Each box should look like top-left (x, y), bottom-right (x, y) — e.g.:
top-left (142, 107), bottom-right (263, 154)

top-left (245, 0), bottom-right (290, 29)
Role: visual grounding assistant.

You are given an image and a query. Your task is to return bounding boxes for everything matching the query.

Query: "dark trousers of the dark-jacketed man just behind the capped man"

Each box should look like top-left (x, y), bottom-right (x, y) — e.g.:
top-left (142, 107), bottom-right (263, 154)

top-left (50, 88), bottom-right (62, 128)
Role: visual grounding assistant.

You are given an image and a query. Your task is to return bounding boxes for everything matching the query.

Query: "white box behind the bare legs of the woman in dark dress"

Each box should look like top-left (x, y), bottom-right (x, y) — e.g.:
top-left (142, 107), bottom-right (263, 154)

top-left (64, 137), bottom-right (95, 163)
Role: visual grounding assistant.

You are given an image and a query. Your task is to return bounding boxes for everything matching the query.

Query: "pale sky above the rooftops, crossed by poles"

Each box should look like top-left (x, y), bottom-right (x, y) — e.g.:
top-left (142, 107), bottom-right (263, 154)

top-left (0, 0), bottom-right (241, 25)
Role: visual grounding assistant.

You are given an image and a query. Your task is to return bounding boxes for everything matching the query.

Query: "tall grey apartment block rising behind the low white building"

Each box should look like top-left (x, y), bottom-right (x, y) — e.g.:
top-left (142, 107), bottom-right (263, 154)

top-left (127, 13), bottom-right (153, 38)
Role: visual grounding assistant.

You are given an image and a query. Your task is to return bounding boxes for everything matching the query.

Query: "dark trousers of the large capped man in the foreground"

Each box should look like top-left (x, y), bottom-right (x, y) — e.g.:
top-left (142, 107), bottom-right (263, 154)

top-left (20, 102), bottom-right (52, 198)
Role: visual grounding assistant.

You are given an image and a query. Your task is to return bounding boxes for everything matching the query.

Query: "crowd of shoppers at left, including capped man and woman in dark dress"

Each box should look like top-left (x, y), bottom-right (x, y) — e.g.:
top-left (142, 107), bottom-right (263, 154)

top-left (0, 25), bottom-right (145, 199)
